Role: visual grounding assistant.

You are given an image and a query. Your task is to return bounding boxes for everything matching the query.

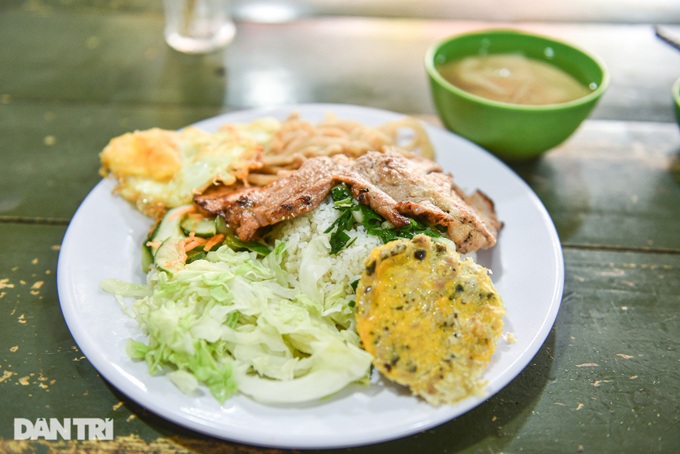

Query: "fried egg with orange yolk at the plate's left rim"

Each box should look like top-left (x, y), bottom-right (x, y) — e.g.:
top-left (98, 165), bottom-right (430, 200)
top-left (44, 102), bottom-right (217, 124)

top-left (100, 118), bottom-right (280, 217)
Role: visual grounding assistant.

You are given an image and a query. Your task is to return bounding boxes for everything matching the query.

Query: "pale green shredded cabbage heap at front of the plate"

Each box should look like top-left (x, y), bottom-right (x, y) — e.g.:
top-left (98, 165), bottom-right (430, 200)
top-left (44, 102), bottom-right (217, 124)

top-left (102, 242), bottom-right (371, 403)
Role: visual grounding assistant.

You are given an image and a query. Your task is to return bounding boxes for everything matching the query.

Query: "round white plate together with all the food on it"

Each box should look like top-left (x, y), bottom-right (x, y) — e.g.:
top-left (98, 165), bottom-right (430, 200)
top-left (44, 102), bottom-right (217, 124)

top-left (58, 104), bottom-right (564, 449)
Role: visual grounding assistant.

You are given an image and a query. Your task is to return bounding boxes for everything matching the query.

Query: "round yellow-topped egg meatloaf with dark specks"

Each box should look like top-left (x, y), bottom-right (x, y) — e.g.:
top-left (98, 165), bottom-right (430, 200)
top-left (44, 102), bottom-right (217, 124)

top-left (357, 235), bottom-right (505, 404)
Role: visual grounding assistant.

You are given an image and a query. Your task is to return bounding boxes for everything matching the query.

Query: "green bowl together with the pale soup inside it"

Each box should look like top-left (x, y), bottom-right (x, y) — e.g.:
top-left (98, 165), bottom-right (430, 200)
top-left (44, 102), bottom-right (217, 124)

top-left (425, 30), bottom-right (609, 160)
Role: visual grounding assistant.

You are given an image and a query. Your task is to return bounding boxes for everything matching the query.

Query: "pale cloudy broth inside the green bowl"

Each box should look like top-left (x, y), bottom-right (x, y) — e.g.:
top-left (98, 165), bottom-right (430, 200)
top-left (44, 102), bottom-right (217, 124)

top-left (437, 53), bottom-right (591, 105)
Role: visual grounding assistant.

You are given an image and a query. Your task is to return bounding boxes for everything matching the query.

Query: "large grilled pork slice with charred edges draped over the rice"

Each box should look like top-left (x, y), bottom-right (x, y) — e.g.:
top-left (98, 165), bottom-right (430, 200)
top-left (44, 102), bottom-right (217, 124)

top-left (194, 151), bottom-right (501, 253)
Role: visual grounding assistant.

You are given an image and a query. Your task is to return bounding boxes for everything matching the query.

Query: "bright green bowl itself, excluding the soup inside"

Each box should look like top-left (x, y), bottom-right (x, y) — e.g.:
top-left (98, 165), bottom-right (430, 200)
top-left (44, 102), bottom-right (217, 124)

top-left (425, 30), bottom-right (612, 160)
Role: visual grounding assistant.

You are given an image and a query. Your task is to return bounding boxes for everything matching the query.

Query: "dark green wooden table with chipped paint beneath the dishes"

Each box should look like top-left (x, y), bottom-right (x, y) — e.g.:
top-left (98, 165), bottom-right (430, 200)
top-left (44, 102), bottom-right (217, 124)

top-left (0, 0), bottom-right (680, 453)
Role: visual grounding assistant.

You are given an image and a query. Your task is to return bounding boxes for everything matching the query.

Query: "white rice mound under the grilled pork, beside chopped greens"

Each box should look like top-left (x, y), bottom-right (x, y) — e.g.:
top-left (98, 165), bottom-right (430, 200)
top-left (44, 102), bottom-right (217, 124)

top-left (276, 196), bottom-right (382, 299)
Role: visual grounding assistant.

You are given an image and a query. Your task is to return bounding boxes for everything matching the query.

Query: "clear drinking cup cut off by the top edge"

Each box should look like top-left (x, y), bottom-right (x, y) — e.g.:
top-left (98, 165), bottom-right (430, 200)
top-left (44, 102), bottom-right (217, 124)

top-left (164, 0), bottom-right (236, 54)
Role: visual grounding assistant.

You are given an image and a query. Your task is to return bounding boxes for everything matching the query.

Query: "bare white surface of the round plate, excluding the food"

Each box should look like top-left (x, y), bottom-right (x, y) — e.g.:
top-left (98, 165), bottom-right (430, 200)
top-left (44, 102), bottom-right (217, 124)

top-left (58, 104), bottom-right (564, 448)
